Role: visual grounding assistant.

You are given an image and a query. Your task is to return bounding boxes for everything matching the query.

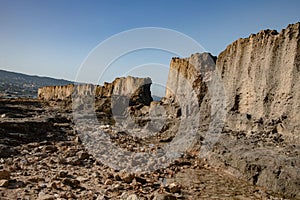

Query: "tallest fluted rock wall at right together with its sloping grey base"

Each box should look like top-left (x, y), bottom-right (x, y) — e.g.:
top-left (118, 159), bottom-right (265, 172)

top-left (212, 23), bottom-right (300, 198)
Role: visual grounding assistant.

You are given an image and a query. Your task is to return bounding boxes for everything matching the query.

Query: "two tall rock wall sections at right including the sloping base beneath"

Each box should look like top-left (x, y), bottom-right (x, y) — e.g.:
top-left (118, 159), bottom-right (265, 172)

top-left (164, 23), bottom-right (300, 199)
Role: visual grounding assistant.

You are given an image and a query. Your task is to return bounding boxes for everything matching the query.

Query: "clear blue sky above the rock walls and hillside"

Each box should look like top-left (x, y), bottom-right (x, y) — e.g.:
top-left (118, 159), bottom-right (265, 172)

top-left (0, 0), bottom-right (300, 96)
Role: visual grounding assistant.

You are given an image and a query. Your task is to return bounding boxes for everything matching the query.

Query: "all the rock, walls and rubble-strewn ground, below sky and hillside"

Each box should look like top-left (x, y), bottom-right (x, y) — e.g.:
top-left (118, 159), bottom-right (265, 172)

top-left (0, 23), bottom-right (300, 199)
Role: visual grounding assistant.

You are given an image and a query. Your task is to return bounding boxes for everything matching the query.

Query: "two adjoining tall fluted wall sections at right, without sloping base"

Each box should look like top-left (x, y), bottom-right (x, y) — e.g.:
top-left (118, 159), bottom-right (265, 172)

top-left (165, 23), bottom-right (300, 140)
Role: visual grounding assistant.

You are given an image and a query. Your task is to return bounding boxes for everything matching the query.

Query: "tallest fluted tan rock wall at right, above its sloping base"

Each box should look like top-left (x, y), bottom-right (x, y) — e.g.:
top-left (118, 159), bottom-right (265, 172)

top-left (217, 23), bottom-right (300, 137)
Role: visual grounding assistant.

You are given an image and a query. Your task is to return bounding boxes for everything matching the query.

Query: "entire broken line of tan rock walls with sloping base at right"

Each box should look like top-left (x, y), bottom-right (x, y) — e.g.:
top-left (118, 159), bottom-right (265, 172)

top-left (34, 23), bottom-right (300, 199)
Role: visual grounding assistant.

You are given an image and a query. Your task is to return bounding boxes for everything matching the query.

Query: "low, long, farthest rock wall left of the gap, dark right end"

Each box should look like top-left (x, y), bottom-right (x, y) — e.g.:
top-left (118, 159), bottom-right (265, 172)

top-left (38, 76), bottom-right (152, 105)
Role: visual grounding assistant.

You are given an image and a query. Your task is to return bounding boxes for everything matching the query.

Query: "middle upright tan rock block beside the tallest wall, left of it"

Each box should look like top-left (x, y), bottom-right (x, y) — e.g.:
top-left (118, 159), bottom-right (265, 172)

top-left (163, 53), bottom-right (216, 122)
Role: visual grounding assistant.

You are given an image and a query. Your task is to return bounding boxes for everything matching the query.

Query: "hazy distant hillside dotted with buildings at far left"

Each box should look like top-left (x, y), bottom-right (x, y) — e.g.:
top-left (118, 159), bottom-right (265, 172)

top-left (0, 69), bottom-right (72, 97)
